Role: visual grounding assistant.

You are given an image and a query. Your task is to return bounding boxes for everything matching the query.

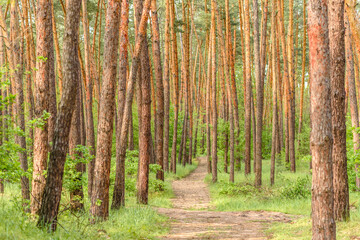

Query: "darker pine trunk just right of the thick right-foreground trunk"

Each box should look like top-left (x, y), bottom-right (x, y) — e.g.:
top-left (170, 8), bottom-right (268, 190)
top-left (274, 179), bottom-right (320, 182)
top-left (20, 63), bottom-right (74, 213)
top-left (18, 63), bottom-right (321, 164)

top-left (328, 0), bottom-right (348, 221)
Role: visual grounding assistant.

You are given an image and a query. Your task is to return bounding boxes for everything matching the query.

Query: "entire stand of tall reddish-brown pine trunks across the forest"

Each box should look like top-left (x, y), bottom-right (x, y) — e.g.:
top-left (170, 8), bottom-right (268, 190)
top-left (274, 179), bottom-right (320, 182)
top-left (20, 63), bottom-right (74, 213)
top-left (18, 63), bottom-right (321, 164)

top-left (0, 0), bottom-right (360, 236)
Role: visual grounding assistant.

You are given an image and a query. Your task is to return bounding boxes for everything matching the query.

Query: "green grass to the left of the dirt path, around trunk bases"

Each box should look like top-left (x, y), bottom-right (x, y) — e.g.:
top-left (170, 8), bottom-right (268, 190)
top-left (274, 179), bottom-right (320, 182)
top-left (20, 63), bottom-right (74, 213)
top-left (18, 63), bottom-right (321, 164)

top-left (0, 162), bottom-right (197, 240)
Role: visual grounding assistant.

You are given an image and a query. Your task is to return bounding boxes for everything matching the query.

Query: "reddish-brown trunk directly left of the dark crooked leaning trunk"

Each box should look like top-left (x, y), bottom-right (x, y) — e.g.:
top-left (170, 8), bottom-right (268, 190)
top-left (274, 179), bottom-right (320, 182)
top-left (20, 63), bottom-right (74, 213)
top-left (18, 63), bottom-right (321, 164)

top-left (31, 0), bottom-right (54, 214)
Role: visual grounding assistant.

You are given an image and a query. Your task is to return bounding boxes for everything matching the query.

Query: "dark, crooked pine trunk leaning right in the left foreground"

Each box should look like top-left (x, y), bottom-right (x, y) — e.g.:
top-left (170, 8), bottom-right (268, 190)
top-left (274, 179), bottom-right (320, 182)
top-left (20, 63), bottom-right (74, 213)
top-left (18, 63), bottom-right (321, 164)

top-left (38, 0), bottom-right (81, 231)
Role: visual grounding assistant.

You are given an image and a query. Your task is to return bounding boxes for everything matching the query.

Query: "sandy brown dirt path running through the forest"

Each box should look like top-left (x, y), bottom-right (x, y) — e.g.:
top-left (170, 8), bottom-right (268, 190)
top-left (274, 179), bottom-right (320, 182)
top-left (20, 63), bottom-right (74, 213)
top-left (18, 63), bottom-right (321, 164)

top-left (158, 158), bottom-right (290, 239)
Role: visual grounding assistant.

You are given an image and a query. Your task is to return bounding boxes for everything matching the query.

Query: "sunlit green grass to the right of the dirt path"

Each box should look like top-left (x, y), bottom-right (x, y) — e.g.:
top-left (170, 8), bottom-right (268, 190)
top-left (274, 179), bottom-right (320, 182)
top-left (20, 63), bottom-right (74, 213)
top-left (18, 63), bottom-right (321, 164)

top-left (205, 158), bottom-right (360, 240)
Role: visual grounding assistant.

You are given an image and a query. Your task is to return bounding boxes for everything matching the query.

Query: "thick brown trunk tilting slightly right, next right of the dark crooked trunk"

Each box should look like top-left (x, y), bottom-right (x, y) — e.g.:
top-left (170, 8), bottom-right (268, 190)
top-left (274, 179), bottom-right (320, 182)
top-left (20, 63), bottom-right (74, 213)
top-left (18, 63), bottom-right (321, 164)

top-left (90, 0), bottom-right (120, 220)
